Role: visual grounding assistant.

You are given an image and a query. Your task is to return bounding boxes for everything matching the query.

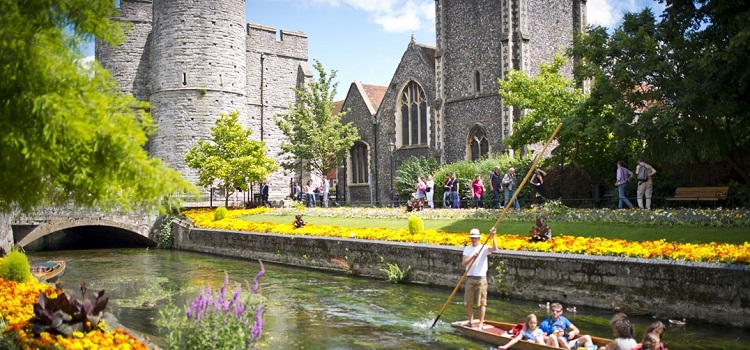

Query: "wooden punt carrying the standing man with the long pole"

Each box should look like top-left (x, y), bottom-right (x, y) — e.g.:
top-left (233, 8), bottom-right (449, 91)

top-left (451, 319), bottom-right (612, 350)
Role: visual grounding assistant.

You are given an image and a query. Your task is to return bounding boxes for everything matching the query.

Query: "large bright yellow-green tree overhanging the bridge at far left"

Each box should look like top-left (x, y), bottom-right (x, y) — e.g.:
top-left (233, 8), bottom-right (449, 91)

top-left (0, 0), bottom-right (192, 211)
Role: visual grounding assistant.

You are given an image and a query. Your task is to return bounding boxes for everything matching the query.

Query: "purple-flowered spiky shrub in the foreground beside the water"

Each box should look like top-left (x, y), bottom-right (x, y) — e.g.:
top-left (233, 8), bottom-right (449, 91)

top-left (157, 264), bottom-right (265, 350)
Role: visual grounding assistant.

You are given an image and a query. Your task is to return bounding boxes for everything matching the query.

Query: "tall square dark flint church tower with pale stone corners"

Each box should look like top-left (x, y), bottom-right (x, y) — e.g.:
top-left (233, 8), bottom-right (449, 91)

top-left (434, 0), bottom-right (586, 162)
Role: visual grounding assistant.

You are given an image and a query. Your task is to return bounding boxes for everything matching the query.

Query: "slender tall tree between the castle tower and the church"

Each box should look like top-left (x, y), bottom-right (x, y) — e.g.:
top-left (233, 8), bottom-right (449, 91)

top-left (274, 60), bottom-right (359, 176)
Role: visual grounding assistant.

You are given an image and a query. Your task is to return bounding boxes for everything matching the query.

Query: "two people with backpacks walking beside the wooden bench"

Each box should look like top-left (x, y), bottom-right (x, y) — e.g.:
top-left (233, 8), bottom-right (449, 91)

top-left (615, 158), bottom-right (656, 209)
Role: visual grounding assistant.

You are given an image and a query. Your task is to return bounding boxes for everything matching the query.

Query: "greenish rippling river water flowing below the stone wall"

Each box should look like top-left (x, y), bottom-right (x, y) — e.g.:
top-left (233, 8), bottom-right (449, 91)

top-left (29, 249), bottom-right (750, 350)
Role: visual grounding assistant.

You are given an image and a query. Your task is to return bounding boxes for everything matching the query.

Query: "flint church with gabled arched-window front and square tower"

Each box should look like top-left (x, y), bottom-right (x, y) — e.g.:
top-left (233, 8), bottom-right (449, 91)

top-left (338, 0), bottom-right (586, 204)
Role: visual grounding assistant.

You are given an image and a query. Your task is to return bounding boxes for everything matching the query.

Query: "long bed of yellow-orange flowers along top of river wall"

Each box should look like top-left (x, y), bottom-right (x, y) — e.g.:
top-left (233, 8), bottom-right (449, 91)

top-left (184, 208), bottom-right (750, 264)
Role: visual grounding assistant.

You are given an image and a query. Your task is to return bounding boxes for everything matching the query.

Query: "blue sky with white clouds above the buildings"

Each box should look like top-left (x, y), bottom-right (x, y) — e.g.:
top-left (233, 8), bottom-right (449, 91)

top-left (87, 0), bottom-right (664, 100)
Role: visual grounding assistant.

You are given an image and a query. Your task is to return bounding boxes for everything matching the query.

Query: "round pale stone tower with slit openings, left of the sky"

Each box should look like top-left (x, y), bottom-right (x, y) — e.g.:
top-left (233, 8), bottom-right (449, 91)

top-left (149, 0), bottom-right (247, 182)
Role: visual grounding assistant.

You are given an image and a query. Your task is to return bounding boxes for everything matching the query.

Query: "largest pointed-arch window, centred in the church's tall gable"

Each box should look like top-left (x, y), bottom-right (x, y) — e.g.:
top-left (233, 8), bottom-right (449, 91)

top-left (400, 80), bottom-right (427, 146)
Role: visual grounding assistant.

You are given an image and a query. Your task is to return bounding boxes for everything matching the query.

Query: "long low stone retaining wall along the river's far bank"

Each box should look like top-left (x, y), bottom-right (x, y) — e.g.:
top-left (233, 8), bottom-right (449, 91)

top-left (172, 220), bottom-right (750, 328)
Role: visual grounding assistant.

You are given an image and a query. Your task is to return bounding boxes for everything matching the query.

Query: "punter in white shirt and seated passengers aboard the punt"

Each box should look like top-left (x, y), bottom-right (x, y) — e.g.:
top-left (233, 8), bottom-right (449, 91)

top-left (461, 227), bottom-right (665, 350)
